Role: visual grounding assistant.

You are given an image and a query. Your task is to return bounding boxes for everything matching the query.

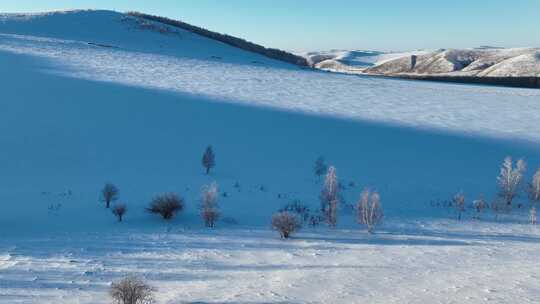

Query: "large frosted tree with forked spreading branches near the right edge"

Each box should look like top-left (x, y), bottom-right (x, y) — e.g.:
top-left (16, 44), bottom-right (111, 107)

top-left (497, 156), bottom-right (526, 206)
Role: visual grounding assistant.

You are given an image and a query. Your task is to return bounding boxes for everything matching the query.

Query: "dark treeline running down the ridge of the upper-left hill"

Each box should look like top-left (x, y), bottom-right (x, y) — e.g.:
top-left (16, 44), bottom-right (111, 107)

top-left (128, 12), bottom-right (309, 66)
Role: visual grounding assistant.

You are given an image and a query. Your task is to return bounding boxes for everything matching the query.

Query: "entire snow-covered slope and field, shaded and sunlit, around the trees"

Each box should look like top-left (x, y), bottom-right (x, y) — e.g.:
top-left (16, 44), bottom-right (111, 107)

top-left (0, 11), bottom-right (540, 303)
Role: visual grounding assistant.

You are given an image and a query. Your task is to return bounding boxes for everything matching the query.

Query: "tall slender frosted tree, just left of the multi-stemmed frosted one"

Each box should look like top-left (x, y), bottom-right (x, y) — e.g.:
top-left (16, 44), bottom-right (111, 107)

top-left (320, 166), bottom-right (339, 227)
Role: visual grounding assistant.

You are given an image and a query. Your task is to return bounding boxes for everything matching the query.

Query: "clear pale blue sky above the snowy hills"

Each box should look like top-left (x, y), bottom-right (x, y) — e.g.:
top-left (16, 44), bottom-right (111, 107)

top-left (0, 0), bottom-right (540, 51)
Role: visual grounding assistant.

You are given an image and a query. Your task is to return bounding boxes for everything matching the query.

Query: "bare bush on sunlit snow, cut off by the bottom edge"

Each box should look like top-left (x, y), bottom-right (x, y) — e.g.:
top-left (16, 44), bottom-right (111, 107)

top-left (109, 276), bottom-right (154, 304)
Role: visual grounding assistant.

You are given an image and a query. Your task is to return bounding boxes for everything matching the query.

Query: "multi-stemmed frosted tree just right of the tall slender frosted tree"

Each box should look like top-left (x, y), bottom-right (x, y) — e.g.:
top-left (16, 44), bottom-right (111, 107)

top-left (356, 189), bottom-right (384, 233)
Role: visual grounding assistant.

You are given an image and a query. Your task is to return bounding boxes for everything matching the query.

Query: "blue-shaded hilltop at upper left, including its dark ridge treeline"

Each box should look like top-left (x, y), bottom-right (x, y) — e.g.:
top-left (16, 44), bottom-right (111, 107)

top-left (0, 10), bottom-right (308, 66)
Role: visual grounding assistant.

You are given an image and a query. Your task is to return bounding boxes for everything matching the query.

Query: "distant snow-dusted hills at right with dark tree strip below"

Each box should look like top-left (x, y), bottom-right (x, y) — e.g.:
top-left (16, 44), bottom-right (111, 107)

top-left (301, 46), bottom-right (540, 87)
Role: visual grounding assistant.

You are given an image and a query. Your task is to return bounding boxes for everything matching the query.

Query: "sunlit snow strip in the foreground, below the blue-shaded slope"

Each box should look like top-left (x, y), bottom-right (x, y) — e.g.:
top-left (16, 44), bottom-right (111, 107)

top-left (0, 223), bottom-right (540, 303)
